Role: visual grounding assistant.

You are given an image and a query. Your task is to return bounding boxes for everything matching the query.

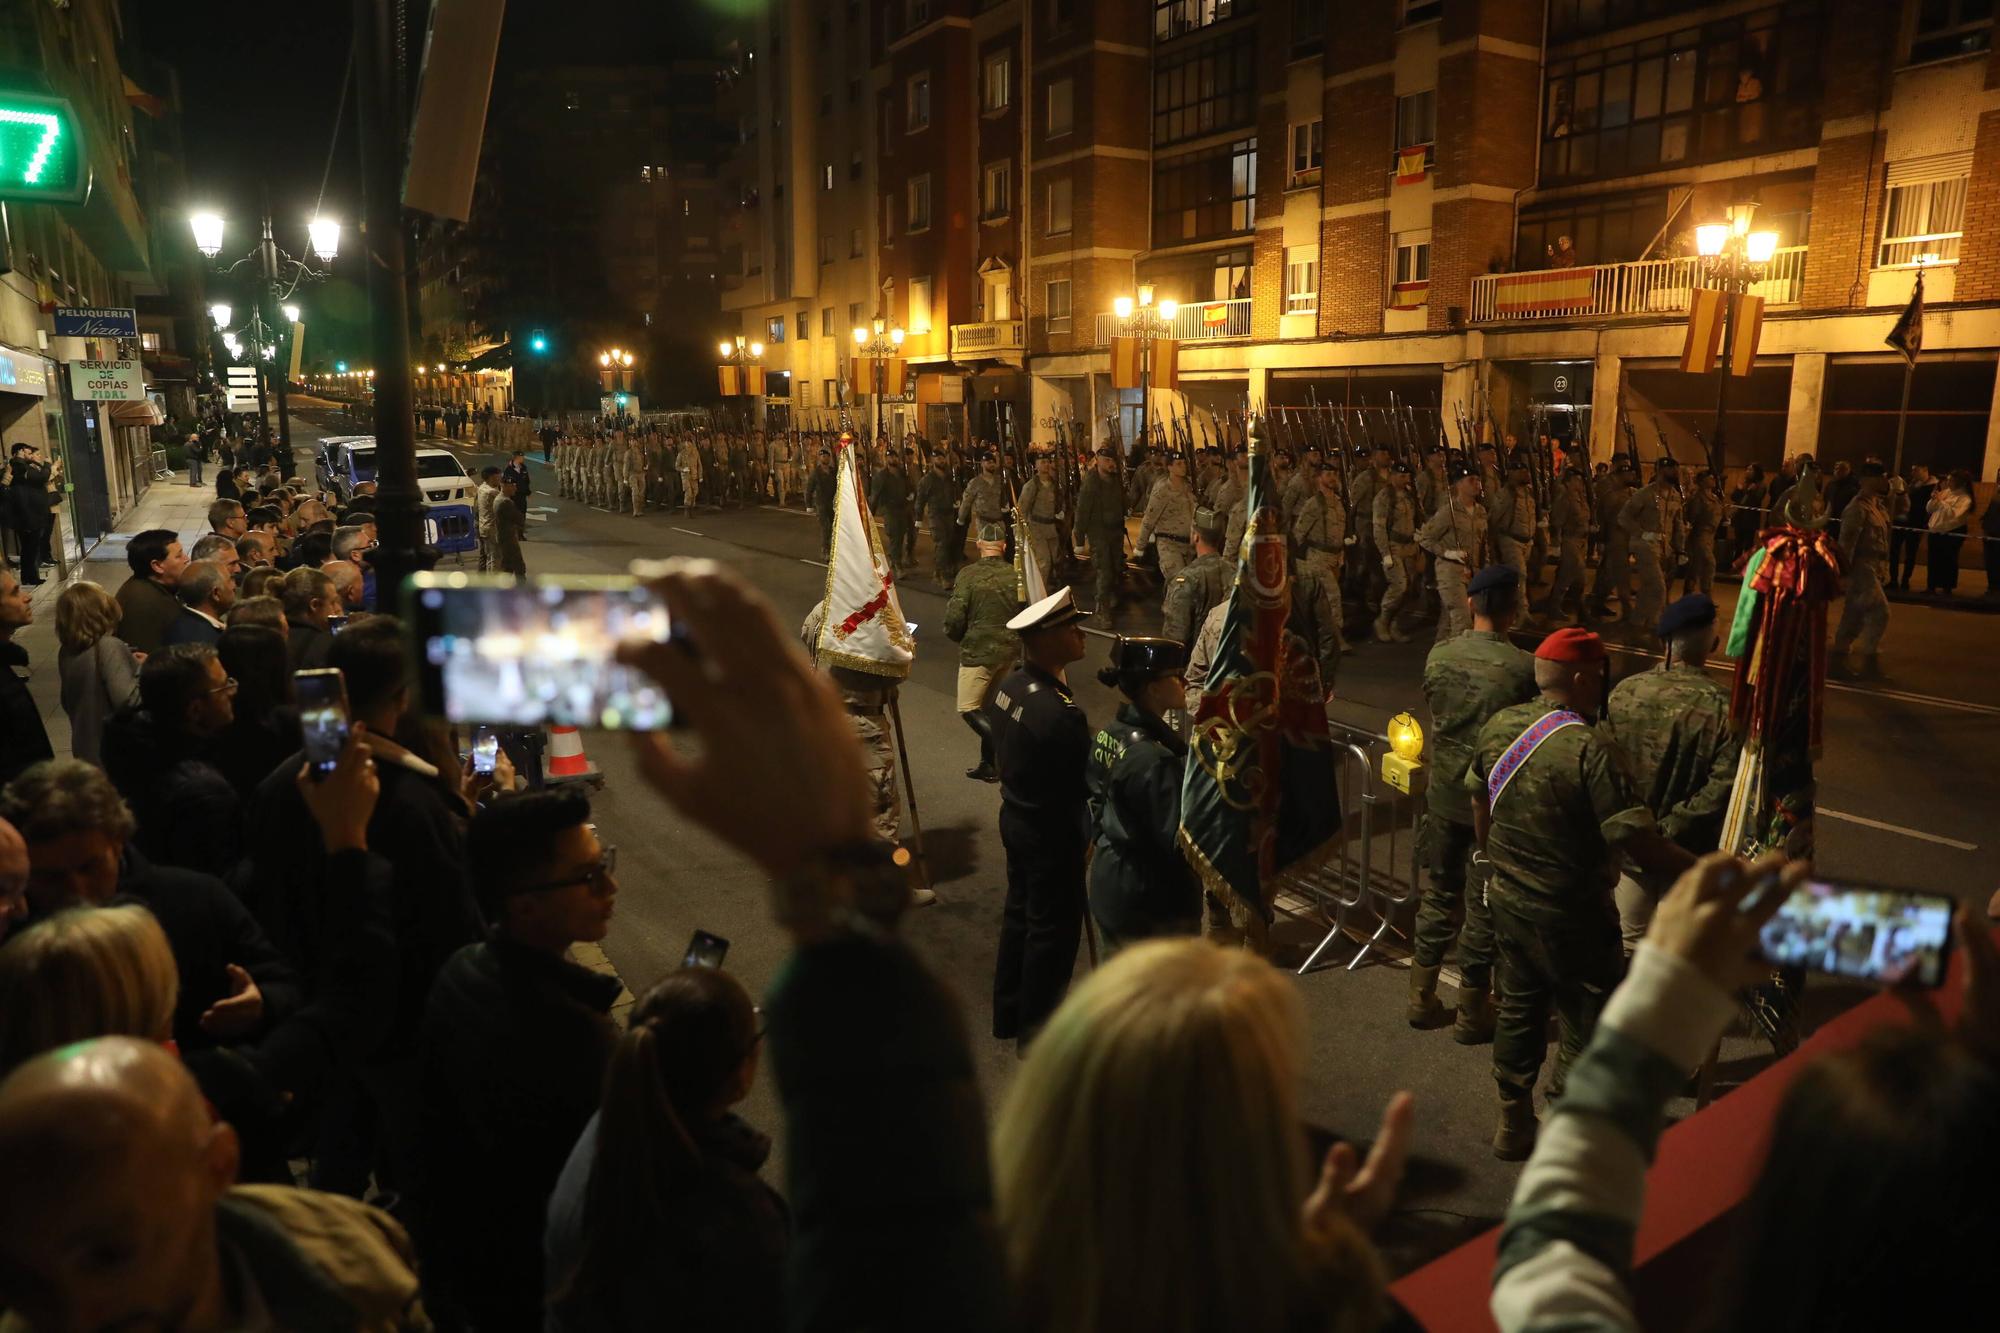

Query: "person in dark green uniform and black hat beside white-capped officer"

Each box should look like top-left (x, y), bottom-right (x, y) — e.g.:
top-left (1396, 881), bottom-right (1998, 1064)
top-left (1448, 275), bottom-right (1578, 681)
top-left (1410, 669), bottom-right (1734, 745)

top-left (1084, 638), bottom-right (1202, 953)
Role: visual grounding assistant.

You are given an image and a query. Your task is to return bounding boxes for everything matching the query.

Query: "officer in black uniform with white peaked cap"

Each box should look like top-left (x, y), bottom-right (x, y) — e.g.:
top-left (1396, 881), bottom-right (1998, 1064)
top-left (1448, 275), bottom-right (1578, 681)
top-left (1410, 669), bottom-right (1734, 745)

top-left (990, 588), bottom-right (1090, 1047)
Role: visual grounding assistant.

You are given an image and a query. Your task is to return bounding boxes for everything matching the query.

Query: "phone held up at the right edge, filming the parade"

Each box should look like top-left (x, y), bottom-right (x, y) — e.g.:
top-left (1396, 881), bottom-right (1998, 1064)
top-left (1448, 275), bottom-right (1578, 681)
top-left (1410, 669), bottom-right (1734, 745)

top-left (1758, 879), bottom-right (1956, 987)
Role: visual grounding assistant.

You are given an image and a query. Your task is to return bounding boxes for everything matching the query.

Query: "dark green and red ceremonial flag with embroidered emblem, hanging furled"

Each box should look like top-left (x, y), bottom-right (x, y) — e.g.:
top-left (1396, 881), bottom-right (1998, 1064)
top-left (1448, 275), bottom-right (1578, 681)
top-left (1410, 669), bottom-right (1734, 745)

top-left (1180, 422), bottom-right (1340, 945)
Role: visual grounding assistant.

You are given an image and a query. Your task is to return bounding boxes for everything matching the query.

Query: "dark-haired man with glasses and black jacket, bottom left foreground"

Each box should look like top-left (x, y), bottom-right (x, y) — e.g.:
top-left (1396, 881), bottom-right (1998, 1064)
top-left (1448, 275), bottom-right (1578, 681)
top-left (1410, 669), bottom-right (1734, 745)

top-left (416, 787), bottom-right (620, 1333)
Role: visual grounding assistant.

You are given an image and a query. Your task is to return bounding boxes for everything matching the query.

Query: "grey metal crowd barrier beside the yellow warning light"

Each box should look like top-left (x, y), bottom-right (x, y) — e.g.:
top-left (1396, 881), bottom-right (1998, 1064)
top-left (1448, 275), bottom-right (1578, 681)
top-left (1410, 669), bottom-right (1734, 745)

top-left (1298, 723), bottom-right (1422, 977)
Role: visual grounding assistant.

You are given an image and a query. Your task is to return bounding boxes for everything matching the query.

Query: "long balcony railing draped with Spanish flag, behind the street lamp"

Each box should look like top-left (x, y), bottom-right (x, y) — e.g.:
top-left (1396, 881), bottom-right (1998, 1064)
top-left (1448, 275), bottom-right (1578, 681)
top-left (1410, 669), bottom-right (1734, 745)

top-left (1472, 246), bottom-right (1806, 324)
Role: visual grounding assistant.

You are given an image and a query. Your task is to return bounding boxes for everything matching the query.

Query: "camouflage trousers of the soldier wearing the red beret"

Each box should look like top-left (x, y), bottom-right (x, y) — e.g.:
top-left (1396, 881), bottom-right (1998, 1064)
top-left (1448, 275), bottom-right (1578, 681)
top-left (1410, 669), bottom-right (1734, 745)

top-left (1488, 897), bottom-right (1624, 1095)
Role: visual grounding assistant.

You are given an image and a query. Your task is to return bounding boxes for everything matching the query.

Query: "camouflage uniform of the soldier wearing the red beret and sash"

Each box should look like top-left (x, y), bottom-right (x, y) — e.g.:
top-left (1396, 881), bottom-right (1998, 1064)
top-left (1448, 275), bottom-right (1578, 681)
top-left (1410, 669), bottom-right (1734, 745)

top-left (1466, 699), bottom-right (1654, 1103)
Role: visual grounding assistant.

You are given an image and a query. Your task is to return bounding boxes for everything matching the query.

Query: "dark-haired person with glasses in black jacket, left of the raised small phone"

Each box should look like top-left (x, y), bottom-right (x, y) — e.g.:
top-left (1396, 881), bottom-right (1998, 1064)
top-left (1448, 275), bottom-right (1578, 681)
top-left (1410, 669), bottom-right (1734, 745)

top-left (104, 642), bottom-right (242, 879)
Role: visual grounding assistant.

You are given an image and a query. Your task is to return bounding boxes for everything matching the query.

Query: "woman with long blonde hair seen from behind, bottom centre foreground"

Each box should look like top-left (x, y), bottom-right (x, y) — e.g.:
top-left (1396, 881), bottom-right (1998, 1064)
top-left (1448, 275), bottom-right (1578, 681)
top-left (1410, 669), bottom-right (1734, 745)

top-left (994, 939), bottom-right (1382, 1333)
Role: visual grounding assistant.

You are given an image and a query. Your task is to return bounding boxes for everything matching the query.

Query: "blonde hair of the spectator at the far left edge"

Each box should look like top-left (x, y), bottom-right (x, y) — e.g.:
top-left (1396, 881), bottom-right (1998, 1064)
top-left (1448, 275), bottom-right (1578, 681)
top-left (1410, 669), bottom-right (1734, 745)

top-left (0, 903), bottom-right (180, 1077)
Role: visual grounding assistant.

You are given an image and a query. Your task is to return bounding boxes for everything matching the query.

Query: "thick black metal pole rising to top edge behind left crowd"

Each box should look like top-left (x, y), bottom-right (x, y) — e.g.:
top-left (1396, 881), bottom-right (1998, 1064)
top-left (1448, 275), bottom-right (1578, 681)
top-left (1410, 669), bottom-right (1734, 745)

top-left (354, 0), bottom-right (428, 610)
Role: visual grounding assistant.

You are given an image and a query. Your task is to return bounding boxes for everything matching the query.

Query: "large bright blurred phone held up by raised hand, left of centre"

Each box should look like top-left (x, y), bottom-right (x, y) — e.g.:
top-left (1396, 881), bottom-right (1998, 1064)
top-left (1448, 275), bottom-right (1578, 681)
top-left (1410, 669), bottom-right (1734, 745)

top-left (412, 574), bottom-right (674, 731)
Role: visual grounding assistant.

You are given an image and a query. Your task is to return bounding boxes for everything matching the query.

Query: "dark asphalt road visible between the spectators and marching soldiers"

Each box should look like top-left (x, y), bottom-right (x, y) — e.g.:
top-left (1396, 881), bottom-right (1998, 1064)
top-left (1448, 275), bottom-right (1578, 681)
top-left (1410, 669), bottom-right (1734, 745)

top-left (320, 412), bottom-right (2000, 1271)
